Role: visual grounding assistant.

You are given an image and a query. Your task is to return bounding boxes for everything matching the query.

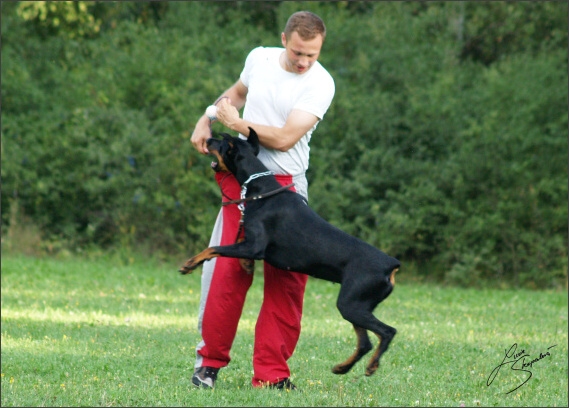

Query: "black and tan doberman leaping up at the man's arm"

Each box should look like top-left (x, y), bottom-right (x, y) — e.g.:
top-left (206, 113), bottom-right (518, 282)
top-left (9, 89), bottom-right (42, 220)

top-left (179, 128), bottom-right (400, 376)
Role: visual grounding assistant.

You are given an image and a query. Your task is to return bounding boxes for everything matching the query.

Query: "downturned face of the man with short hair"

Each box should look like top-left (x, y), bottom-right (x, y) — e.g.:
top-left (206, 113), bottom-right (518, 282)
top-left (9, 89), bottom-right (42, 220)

top-left (281, 31), bottom-right (322, 74)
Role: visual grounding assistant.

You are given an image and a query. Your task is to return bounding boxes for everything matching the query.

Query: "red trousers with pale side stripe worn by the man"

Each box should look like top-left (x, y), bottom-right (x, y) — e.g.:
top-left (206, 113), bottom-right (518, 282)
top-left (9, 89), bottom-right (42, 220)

top-left (196, 173), bottom-right (308, 387)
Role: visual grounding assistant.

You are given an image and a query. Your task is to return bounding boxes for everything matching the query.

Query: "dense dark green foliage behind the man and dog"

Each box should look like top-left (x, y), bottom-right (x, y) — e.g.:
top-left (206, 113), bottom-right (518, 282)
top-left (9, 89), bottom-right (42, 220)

top-left (1, 1), bottom-right (568, 288)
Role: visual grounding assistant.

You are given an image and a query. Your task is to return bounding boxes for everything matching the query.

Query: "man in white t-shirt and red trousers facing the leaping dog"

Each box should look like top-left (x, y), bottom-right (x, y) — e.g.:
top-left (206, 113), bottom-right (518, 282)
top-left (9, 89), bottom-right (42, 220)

top-left (191, 11), bottom-right (335, 389)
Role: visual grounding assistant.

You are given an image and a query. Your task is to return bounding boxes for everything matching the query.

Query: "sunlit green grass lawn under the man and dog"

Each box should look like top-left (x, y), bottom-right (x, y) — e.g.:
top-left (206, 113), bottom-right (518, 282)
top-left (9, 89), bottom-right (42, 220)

top-left (1, 255), bottom-right (568, 406)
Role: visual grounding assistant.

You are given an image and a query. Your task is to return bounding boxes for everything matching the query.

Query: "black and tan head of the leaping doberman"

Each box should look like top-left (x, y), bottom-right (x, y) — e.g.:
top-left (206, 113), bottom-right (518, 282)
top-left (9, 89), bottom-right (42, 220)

top-left (207, 128), bottom-right (259, 174)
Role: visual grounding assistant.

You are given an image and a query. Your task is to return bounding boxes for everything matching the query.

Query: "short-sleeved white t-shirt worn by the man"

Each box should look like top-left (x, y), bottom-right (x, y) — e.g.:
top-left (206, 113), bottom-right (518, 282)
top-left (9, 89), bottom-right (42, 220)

top-left (240, 47), bottom-right (335, 198)
